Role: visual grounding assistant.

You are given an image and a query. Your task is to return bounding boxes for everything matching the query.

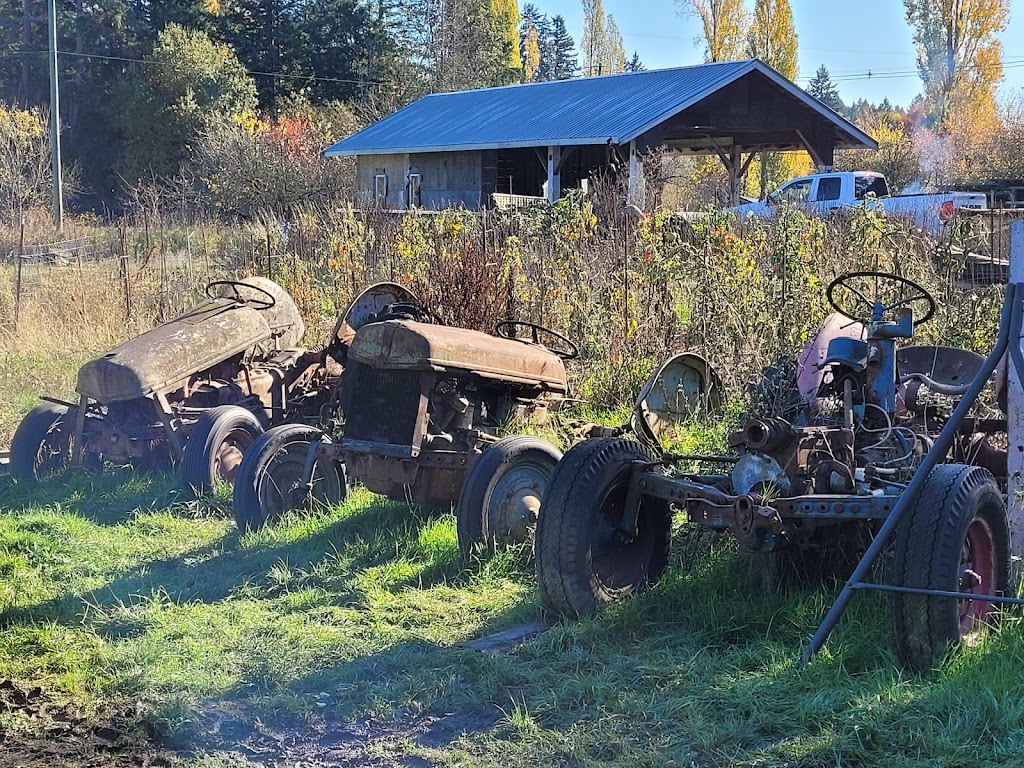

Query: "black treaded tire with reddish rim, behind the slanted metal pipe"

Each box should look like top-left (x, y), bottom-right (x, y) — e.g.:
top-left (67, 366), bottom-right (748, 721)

top-left (893, 464), bottom-right (1010, 669)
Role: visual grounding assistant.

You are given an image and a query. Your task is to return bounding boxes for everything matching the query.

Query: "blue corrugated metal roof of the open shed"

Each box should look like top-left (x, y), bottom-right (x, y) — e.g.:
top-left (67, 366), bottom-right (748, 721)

top-left (325, 59), bottom-right (874, 157)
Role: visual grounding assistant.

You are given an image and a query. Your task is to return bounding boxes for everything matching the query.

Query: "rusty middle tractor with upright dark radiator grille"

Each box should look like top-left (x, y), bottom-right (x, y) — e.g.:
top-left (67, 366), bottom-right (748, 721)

top-left (234, 313), bottom-right (578, 550)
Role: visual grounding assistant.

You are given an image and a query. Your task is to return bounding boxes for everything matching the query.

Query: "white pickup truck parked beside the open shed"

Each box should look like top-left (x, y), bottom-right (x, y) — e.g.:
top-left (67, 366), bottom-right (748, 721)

top-left (732, 171), bottom-right (988, 231)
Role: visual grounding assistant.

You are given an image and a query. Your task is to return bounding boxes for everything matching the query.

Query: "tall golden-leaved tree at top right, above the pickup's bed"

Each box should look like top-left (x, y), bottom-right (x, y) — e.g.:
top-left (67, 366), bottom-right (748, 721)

top-left (904, 0), bottom-right (1010, 127)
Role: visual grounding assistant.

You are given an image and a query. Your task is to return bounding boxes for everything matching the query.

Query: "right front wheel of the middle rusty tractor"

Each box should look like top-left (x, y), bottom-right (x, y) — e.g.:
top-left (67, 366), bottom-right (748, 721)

top-left (456, 435), bottom-right (562, 553)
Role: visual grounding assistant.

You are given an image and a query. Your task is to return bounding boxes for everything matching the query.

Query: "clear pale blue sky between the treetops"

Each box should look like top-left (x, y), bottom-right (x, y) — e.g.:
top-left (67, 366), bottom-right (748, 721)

top-left (532, 0), bottom-right (1024, 106)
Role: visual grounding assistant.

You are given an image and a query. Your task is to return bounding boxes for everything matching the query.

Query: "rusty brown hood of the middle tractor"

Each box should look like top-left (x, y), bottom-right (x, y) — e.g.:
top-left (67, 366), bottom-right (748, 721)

top-left (348, 321), bottom-right (566, 392)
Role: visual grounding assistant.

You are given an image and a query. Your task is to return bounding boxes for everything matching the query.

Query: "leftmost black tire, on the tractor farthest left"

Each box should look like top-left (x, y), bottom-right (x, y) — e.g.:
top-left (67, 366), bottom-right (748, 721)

top-left (10, 402), bottom-right (74, 483)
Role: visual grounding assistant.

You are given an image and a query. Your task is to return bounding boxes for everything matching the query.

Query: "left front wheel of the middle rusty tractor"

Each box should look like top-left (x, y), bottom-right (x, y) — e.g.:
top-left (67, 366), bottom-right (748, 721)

top-left (232, 424), bottom-right (348, 534)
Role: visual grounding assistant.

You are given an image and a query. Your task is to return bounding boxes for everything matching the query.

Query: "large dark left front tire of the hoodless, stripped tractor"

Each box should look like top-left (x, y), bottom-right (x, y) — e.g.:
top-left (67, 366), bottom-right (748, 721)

top-left (535, 437), bottom-right (672, 616)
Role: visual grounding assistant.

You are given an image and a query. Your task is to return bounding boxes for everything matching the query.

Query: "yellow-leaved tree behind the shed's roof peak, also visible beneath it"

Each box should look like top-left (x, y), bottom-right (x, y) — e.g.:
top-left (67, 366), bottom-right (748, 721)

top-left (746, 0), bottom-right (804, 198)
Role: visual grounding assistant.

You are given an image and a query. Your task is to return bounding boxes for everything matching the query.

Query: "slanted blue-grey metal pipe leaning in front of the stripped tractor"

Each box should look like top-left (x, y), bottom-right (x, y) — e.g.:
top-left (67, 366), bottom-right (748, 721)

top-left (797, 283), bottom-right (1024, 670)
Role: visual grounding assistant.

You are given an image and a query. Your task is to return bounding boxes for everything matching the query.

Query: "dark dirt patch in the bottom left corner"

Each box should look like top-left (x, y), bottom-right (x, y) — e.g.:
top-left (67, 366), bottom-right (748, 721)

top-left (0, 680), bottom-right (171, 768)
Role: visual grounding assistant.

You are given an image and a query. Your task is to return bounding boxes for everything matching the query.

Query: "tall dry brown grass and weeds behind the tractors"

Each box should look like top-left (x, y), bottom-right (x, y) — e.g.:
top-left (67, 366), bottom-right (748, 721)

top-left (0, 196), bottom-right (1001, 442)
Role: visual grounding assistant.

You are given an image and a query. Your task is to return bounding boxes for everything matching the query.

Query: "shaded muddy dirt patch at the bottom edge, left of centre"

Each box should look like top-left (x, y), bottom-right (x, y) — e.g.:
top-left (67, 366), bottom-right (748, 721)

top-left (186, 703), bottom-right (496, 768)
